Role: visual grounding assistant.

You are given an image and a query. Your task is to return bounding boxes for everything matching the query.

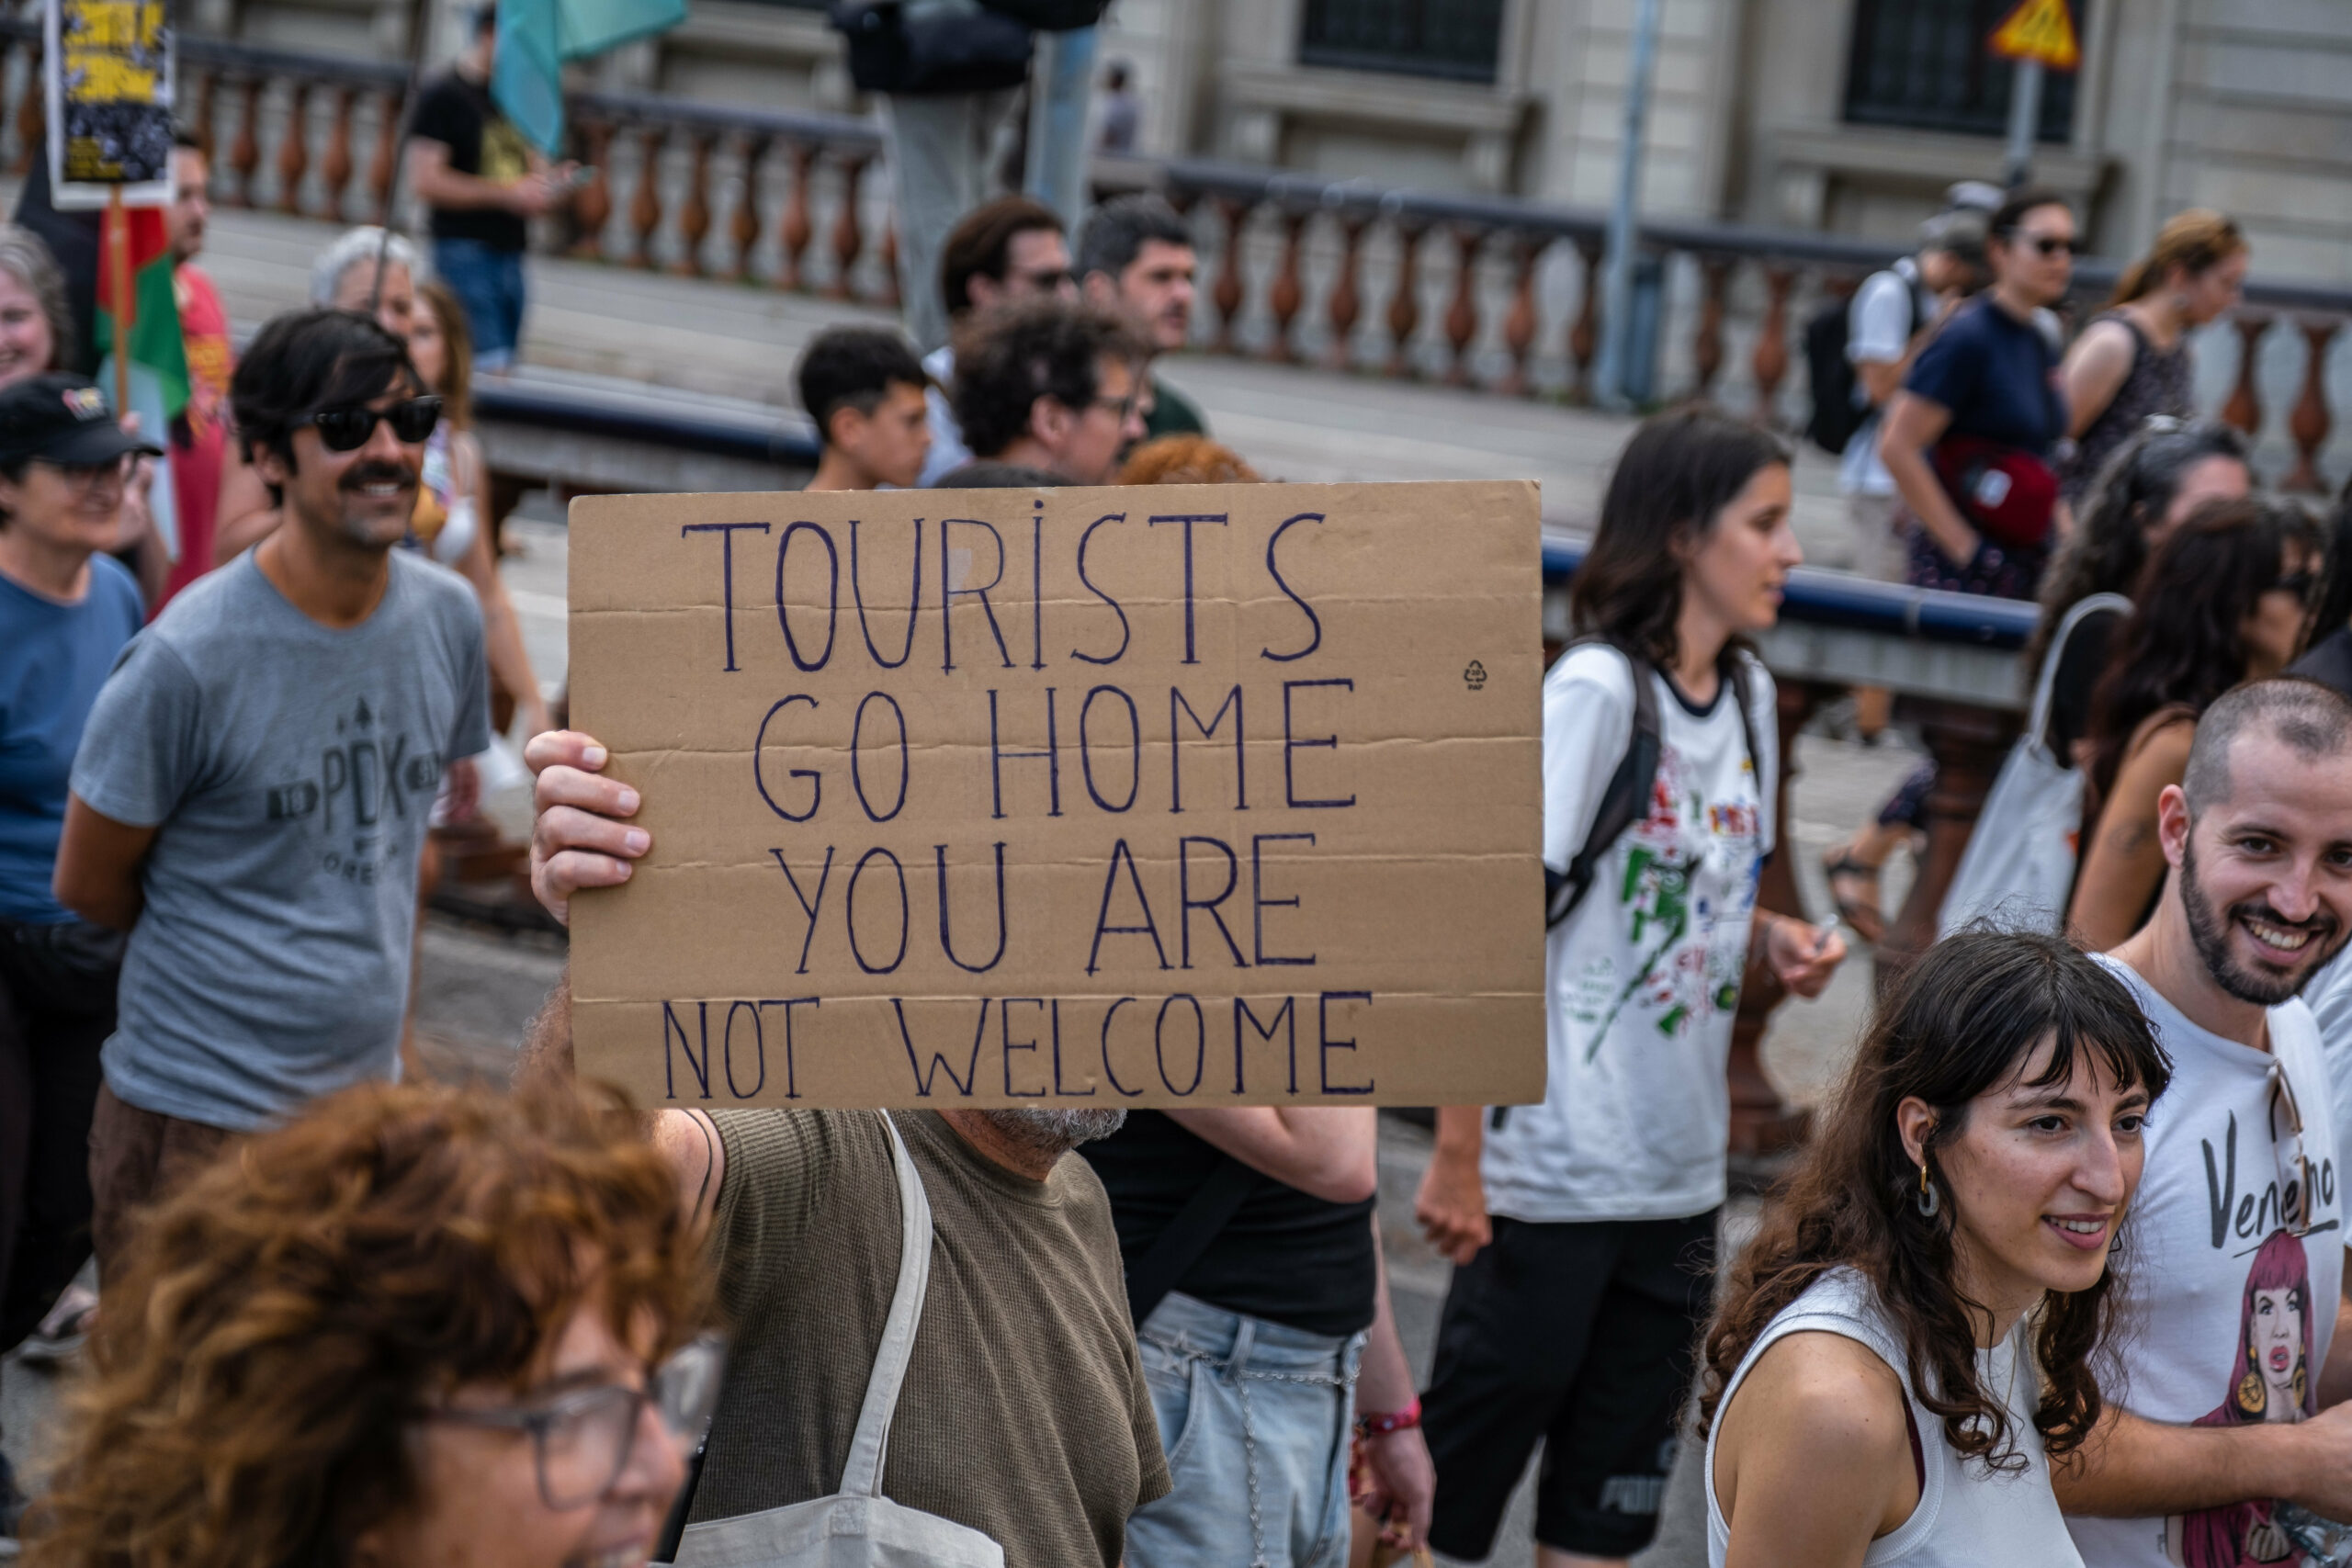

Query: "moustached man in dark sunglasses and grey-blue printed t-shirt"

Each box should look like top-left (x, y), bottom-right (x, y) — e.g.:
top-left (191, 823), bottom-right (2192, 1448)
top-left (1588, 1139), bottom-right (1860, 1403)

top-left (56, 310), bottom-right (489, 1283)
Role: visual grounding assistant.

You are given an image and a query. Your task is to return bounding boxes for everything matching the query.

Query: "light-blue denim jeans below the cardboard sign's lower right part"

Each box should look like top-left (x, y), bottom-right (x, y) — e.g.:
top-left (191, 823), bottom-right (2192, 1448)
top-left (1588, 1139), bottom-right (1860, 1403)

top-left (1126, 1293), bottom-right (1364, 1568)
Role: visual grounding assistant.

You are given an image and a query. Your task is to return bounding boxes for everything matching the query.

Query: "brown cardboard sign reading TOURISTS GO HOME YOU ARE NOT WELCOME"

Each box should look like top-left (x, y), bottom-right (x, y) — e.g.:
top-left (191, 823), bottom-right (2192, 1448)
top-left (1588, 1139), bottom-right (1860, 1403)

top-left (571, 482), bottom-right (1543, 1107)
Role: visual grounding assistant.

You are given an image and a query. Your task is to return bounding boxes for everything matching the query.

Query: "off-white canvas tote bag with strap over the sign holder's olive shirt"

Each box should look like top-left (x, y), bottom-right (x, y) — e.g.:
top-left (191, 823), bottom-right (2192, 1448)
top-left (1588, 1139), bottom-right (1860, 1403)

top-left (677, 1112), bottom-right (1004, 1568)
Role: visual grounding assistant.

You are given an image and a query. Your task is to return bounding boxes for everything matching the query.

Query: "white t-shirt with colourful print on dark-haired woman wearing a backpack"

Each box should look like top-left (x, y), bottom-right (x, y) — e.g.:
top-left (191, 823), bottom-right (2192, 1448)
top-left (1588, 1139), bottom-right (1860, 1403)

top-left (1482, 644), bottom-right (1778, 1223)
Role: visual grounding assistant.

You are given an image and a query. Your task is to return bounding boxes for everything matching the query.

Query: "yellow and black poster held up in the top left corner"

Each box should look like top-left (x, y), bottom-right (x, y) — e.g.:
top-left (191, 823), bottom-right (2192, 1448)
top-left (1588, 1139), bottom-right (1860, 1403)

top-left (42, 0), bottom-right (172, 211)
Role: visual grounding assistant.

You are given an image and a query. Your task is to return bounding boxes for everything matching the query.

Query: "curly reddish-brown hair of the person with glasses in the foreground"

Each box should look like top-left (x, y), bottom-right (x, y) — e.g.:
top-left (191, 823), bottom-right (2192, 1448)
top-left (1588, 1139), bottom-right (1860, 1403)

top-left (24, 1084), bottom-right (708, 1568)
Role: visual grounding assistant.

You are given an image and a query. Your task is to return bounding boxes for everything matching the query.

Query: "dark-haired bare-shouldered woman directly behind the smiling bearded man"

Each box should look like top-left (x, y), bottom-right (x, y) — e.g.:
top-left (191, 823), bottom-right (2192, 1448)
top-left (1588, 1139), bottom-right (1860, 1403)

top-left (2067, 499), bottom-right (2324, 952)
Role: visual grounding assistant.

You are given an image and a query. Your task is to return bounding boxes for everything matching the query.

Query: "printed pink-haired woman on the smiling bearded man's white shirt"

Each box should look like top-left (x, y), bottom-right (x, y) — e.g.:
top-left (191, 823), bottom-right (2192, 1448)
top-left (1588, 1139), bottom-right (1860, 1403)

top-left (2164, 1229), bottom-right (2319, 1568)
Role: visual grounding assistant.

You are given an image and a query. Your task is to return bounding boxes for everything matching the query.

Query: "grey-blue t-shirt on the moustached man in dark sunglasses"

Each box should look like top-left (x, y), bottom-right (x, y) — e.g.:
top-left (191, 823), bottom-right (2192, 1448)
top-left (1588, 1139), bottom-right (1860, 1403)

top-left (73, 550), bottom-right (489, 1131)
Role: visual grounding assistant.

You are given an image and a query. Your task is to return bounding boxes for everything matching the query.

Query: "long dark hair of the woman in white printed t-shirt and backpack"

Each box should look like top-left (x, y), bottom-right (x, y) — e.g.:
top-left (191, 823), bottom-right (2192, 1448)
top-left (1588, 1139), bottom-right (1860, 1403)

top-left (1569, 404), bottom-right (1794, 665)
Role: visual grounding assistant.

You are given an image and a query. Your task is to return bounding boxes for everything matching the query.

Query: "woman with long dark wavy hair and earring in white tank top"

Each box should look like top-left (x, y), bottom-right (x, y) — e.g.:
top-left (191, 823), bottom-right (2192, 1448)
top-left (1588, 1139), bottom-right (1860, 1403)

top-left (1701, 931), bottom-right (2171, 1568)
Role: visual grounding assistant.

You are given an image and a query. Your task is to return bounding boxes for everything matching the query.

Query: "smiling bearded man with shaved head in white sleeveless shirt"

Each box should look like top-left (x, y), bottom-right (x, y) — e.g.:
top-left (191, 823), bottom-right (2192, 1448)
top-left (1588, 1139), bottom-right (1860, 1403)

top-left (2051, 680), bottom-right (2352, 1568)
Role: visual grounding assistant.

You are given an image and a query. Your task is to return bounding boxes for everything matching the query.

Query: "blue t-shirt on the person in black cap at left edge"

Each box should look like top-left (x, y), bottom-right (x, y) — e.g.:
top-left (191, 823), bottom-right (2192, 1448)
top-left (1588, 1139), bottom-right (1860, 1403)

top-left (0, 555), bottom-right (146, 926)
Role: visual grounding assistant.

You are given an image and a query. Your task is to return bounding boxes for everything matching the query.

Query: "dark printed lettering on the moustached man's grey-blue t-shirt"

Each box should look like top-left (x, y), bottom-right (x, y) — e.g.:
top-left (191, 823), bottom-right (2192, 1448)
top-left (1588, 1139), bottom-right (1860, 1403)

top-left (268, 696), bottom-right (442, 886)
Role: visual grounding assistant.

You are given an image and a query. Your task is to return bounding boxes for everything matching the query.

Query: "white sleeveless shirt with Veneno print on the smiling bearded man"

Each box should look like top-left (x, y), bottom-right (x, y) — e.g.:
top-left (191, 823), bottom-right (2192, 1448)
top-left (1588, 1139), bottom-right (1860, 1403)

top-left (2067, 957), bottom-right (2345, 1568)
